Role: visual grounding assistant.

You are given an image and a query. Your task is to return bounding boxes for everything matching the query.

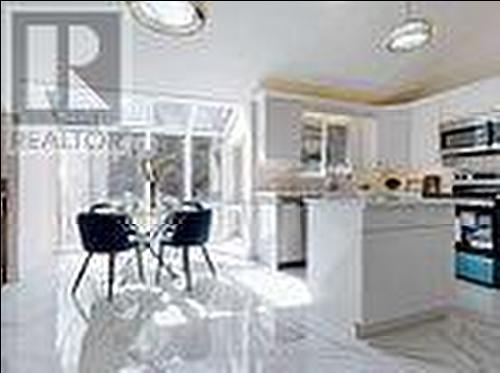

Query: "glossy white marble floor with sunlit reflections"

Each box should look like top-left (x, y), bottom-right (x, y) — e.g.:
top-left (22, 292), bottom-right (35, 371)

top-left (1, 250), bottom-right (500, 373)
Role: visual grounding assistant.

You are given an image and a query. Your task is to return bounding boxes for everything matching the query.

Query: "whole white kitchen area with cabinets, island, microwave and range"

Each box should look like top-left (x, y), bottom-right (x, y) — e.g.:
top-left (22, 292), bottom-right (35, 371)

top-left (256, 78), bottom-right (500, 335)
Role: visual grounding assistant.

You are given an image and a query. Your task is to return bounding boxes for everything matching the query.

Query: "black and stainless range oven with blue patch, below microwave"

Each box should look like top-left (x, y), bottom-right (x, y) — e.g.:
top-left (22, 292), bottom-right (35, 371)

top-left (452, 173), bottom-right (500, 288)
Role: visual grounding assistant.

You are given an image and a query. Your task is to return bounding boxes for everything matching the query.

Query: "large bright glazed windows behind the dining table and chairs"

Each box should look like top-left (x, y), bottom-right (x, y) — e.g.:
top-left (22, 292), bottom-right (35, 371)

top-left (58, 96), bottom-right (236, 248)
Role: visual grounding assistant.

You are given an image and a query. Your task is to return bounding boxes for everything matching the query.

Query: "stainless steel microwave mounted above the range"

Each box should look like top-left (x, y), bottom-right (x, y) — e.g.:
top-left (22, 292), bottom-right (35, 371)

top-left (440, 113), bottom-right (500, 158)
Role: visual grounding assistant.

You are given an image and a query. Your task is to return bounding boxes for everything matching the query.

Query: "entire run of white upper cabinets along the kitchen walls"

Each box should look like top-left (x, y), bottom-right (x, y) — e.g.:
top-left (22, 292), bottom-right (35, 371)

top-left (256, 77), bottom-right (500, 173)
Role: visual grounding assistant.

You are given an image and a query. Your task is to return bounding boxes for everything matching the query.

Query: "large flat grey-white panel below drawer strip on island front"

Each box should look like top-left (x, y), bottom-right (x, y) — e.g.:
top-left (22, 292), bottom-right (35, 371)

top-left (361, 227), bottom-right (454, 323)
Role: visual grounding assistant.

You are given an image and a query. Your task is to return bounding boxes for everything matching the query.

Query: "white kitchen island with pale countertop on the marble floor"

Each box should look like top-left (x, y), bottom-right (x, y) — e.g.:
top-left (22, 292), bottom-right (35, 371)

top-left (306, 196), bottom-right (454, 337)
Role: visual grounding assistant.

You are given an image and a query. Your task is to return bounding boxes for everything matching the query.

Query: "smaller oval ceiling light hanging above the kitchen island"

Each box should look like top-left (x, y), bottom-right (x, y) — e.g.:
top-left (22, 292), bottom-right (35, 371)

top-left (384, 1), bottom-right (435, 53)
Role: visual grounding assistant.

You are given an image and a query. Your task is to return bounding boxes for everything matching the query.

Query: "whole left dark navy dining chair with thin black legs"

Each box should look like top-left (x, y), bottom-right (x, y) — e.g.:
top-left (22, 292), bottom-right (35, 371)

top-left (72, 206), bottom-right (145, 301)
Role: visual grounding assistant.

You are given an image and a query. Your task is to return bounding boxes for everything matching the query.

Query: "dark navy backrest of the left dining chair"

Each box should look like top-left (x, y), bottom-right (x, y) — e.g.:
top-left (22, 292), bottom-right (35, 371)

top-left (77, 212), bottom-right (132, 253)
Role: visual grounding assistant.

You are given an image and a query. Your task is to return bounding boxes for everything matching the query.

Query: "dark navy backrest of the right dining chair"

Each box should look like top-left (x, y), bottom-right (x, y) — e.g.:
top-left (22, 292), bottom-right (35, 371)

top-left (170, 209), bottom-right (212, 246)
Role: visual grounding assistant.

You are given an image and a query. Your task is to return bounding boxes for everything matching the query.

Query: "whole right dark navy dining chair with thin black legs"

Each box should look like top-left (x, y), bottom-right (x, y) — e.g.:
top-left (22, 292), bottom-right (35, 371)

top-left (156, 202), bottom-right (217, 291)
